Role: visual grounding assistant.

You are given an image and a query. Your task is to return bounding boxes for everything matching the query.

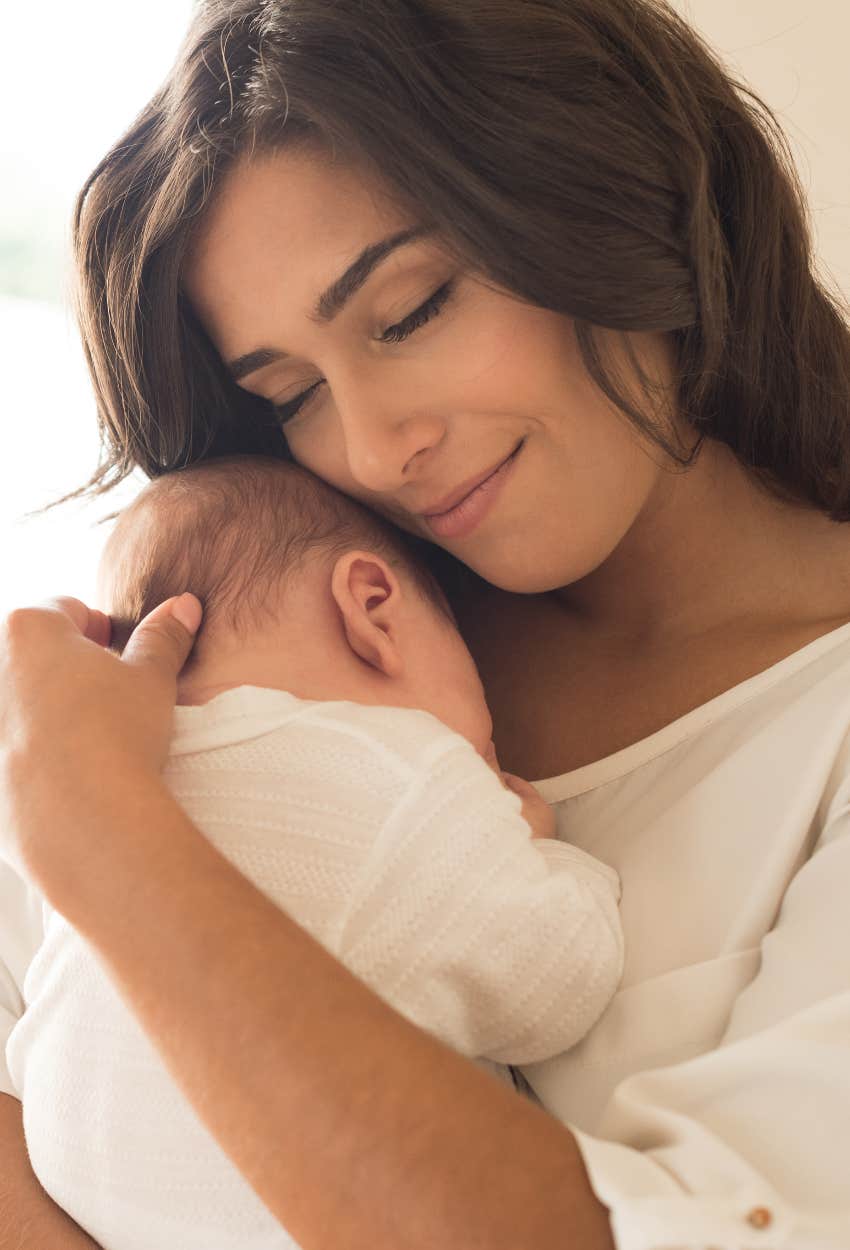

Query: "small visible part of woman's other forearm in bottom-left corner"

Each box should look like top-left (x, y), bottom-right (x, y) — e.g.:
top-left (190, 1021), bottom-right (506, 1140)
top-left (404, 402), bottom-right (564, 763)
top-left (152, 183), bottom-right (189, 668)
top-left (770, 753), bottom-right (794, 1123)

top-left (0, 1094), bottom-right (100, 1250)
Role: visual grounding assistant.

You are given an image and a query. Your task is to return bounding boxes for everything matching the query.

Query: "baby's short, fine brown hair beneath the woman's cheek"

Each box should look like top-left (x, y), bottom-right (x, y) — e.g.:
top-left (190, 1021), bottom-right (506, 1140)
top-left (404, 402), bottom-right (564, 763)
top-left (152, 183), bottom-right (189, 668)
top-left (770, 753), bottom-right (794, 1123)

top-left (103, 455), bottom-right (454, 651)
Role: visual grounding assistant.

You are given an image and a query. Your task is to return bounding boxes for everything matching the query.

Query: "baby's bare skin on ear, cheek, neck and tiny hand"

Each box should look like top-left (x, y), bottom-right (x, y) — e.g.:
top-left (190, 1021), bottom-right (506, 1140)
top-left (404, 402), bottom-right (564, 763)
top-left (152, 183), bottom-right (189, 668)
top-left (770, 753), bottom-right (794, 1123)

top-left (98, 522), bottom-right (555, 838)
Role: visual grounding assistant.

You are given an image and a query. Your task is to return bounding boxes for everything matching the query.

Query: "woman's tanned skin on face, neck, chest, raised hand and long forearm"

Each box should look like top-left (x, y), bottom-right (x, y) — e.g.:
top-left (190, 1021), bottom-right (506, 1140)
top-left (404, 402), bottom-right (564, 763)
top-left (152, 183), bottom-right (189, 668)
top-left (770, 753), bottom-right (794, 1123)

top-left (0, 143), bottom-right (850, 1250)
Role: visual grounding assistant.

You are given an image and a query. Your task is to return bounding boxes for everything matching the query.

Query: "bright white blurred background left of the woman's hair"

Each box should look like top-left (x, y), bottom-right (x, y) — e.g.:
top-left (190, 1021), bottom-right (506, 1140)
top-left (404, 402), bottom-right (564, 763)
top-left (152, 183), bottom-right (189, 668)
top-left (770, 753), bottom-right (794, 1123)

top-left (0, 0), bottom-right (191, 611)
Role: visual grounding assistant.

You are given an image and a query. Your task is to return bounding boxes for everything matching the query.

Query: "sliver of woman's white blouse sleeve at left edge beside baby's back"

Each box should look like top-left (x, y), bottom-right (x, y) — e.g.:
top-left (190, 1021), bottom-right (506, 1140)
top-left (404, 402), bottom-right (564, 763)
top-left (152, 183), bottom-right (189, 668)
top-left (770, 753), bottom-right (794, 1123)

top-left (0, 859), bottom-right (44, 1098)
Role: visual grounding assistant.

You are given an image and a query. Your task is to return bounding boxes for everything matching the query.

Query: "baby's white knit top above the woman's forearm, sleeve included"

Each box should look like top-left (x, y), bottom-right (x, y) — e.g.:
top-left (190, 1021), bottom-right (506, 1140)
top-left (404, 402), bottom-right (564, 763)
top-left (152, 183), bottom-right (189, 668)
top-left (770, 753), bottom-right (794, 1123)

top-left (166, 705), bottom-right (623, 1064)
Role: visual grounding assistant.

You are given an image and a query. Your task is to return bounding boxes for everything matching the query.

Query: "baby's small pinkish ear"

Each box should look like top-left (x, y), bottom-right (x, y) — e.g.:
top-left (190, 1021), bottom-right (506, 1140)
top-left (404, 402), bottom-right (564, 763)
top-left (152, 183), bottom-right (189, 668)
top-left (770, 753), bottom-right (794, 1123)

top-left (330, 551), bottom-right (404, 678)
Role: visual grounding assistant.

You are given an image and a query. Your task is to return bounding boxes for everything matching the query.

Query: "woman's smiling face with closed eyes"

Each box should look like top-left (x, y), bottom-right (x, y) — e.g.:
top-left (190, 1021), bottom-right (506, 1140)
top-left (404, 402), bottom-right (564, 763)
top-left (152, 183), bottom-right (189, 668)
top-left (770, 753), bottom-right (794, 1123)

top-left (185, 150), bottom-right (670, 593)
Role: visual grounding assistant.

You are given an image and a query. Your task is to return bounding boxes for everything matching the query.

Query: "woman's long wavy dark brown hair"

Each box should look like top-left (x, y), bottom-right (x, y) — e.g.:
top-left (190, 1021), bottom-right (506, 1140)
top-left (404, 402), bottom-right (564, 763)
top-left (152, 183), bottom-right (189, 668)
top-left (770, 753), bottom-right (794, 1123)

top-left (74, 0), bottom-right (850, 520)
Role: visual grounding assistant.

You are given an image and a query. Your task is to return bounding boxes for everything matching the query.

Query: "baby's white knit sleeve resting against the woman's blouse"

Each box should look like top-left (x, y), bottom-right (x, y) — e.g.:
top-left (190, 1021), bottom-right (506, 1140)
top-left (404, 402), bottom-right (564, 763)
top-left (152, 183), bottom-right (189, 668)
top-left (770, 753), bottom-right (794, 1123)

top-left (333, 735), bottom-right (623, 1064)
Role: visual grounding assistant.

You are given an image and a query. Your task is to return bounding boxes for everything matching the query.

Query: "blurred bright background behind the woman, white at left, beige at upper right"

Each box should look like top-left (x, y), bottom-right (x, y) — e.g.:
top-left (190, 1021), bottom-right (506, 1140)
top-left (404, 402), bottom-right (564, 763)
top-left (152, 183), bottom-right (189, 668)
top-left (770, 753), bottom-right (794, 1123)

top-left (0, 0), bottom-right (850, 613)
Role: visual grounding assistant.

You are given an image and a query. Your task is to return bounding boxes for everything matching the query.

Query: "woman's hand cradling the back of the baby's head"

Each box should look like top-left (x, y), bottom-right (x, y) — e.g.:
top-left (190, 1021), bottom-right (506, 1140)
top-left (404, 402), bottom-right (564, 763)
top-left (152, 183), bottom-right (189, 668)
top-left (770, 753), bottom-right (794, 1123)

top-left (0, 595), bottom-right (201, 888)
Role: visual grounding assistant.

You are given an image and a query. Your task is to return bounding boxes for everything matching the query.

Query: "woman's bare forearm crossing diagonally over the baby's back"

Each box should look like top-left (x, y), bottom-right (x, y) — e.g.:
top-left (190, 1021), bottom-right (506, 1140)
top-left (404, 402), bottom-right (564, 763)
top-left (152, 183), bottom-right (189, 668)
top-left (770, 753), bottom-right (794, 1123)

top-left (33, 779), bottom-right (613, 1250)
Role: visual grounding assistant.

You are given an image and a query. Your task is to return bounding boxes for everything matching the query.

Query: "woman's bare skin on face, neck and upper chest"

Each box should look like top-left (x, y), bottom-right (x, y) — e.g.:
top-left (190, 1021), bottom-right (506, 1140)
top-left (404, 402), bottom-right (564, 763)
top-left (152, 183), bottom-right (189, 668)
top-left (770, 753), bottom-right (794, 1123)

top-left (185, 149), bottom-right (850, 778)
